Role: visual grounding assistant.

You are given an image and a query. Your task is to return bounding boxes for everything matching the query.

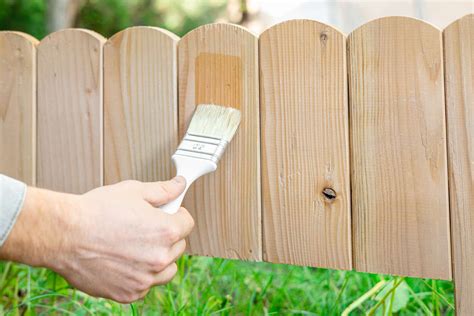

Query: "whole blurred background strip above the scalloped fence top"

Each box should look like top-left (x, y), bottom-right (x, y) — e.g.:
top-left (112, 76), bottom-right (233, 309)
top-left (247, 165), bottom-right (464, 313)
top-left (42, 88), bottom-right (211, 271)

top-left (0, 0), bottom-right (474, 39)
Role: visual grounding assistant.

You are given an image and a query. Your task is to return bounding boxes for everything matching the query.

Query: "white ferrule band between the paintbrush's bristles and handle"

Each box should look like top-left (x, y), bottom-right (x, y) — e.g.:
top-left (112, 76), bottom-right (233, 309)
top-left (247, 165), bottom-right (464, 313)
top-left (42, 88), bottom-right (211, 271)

top-left (175, 133), bottom-right (229, 164)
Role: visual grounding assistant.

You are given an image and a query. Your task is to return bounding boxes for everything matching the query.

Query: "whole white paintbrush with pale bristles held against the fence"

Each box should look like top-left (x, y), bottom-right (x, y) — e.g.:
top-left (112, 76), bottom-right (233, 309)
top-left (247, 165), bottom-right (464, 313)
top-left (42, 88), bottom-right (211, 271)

top-left (160, 104), bottom-right (240, 214)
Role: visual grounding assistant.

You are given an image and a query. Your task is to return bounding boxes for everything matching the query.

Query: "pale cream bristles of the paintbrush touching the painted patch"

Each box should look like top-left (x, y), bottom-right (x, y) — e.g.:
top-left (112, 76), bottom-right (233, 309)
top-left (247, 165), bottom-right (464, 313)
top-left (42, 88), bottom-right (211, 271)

top-left (188, 104), bottom-right (240, 142)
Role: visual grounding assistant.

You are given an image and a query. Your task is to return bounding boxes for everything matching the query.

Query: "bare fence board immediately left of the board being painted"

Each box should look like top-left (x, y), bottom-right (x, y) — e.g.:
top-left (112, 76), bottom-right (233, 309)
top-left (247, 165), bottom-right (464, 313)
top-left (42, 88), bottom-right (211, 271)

top-left (104, 27), bottom-right (178, 184)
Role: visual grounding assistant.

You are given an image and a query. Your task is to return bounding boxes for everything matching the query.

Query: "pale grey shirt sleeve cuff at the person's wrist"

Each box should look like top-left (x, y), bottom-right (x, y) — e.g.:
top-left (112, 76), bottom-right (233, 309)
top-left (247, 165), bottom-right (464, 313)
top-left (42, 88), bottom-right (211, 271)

top-left (0, 174), bottom-right (26, 246)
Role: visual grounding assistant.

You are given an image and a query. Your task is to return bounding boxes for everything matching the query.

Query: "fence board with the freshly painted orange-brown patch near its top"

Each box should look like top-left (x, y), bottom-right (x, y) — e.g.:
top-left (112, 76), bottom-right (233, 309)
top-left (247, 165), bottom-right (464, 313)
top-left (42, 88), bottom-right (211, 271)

top-left (178, 24), bottom-right (262, 260)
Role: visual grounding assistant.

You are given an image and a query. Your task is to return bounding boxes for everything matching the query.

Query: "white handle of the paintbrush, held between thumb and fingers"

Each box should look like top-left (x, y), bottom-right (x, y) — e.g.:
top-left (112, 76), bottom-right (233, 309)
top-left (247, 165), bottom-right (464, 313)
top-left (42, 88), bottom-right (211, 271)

top-left (160, 155), bottom-right (217, 214)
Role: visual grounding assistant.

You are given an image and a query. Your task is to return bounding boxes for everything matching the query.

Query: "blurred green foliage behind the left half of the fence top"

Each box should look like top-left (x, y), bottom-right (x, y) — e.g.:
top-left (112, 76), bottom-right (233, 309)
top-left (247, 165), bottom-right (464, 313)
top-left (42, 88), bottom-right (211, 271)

top-left (0, 0), bottom-right (227, 39)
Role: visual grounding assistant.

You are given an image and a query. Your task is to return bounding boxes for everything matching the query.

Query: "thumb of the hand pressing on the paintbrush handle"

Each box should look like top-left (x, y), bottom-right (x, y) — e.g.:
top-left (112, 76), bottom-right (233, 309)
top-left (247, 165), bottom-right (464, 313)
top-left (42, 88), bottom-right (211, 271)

top-left (143, 176), bottom-right (186, 207)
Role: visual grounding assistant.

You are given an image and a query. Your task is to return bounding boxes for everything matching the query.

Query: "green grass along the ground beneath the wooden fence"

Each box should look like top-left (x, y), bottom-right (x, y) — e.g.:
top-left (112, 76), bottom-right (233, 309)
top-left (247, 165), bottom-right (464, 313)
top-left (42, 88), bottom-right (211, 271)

top-left (0, 256), bottom-right (454, 315)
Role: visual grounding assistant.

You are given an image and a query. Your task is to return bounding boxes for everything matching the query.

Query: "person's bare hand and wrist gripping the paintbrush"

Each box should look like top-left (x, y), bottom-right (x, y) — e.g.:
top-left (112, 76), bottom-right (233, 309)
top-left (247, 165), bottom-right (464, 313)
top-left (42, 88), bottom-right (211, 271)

top-left (0, 178), bottom-right (194, 303)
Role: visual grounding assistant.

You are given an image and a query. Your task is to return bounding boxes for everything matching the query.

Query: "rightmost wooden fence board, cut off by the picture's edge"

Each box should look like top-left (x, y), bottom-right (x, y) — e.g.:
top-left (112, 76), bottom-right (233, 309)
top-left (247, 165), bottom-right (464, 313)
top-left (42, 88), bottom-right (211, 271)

top-left (444, 14), bottom-right (474, 315)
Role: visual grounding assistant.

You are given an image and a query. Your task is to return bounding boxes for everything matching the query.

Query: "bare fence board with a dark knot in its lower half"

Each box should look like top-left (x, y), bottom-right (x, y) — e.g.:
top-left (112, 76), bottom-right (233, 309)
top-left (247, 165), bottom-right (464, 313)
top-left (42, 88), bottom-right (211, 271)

top-left (259, 20), bottom-right (352, 269)
